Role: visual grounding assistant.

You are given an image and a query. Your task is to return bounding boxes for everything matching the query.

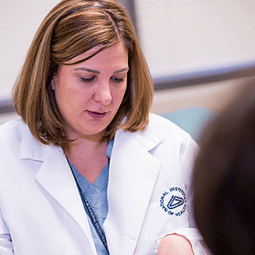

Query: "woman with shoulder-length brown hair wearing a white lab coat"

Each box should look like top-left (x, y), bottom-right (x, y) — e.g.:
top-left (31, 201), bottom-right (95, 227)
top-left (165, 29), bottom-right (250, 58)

top-left (0, 0), bottom-right (204, 255)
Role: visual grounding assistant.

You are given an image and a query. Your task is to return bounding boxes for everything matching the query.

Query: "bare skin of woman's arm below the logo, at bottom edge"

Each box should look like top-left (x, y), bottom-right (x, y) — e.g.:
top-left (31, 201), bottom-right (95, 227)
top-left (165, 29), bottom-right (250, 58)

top-left (157, 234), bottom-right (194, 255)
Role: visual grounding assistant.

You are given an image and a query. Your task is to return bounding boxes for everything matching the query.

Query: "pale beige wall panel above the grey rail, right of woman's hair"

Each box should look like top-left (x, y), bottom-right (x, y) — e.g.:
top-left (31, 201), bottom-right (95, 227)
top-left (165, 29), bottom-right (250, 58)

top-left (135, 0), bottom-right (255, 77)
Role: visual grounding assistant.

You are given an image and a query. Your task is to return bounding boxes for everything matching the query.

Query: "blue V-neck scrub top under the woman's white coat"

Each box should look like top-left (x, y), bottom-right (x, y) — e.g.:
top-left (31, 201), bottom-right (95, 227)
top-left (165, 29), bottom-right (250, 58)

top-left (69, 140), bottom-right (113, 255)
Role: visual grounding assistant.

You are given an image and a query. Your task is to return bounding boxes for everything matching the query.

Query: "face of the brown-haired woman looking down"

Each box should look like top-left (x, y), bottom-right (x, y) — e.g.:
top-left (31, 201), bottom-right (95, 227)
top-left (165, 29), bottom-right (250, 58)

top-left (52, 42), bottom-right (128, 139)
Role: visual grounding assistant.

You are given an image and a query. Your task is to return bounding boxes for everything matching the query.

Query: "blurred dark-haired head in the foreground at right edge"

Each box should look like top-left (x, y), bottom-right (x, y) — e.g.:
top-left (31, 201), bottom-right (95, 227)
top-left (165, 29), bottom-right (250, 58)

top-left (193, 80), bottom-right (255, 255)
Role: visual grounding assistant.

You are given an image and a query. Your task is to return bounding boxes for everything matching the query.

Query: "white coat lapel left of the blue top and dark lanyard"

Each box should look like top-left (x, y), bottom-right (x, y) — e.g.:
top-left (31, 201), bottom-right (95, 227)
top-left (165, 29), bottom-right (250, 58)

top-left (20, 130), bottom-right (96, 254)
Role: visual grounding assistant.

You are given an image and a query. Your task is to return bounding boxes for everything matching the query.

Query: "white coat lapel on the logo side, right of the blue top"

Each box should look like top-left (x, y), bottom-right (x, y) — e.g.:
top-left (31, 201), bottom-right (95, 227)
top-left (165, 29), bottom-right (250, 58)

top-left (104, 126), bottom-right (162, 255)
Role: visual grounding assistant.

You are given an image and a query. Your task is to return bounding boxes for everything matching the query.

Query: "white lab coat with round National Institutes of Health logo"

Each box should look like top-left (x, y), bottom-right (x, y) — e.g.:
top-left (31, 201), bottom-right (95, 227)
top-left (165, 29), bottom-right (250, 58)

top-left (0, 114), bottom-right (205, 255)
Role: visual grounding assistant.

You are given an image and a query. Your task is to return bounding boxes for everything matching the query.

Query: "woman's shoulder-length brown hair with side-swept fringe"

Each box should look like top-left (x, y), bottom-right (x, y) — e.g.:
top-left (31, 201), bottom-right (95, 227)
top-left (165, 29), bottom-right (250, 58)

top-left (13, 0), bottom-right (153, 146)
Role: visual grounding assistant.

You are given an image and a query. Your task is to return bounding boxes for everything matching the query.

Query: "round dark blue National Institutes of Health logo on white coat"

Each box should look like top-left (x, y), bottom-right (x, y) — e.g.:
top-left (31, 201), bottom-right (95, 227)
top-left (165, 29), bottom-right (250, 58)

top-left (160, 187), bottom-right (187, 217)
